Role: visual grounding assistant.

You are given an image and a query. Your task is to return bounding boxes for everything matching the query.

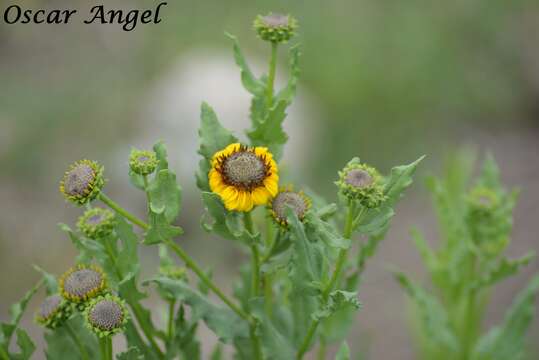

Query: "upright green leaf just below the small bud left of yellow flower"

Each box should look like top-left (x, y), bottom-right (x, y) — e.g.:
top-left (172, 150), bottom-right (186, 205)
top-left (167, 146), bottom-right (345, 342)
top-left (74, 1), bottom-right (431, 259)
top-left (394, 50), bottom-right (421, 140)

top-left (148, 169), bottom-right (181, 223)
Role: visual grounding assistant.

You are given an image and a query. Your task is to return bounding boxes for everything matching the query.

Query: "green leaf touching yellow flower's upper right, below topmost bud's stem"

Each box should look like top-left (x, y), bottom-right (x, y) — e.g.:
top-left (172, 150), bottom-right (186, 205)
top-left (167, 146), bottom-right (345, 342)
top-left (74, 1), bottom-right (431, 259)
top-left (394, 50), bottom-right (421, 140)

top-left (247, 100), bottom-right (288, 161)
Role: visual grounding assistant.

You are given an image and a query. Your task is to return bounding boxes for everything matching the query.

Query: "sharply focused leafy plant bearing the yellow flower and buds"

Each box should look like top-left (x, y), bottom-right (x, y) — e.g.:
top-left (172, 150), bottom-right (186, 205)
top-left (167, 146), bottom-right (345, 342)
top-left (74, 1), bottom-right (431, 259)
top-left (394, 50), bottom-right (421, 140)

top-left (0, 14), bottom-right (421, 360)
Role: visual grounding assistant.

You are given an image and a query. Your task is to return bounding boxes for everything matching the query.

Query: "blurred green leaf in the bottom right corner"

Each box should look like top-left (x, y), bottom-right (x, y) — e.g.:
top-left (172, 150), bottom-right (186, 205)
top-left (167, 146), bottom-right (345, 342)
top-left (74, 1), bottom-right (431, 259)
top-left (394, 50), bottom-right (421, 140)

top-left (472, 275), bottom-right (539, 360)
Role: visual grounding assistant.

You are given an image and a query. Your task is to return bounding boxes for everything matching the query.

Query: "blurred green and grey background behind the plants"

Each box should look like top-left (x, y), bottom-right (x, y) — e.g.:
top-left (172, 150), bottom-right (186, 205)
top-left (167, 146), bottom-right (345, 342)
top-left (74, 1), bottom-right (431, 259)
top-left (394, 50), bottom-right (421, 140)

top-left (0, 0), bottom-right (539, 359)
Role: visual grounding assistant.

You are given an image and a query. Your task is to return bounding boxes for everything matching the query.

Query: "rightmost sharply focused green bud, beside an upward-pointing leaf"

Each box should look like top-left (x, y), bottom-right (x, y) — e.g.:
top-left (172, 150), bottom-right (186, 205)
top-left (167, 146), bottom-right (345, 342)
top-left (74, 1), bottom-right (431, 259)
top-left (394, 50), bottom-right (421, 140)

top-left (335, 158), bottom-right (385, 209)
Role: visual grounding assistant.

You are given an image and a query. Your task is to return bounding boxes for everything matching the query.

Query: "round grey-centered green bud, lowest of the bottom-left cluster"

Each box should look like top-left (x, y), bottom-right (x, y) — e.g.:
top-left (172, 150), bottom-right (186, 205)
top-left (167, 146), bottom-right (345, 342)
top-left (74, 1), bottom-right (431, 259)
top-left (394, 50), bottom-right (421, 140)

top-left (84, 294), bottom-right (129, 337)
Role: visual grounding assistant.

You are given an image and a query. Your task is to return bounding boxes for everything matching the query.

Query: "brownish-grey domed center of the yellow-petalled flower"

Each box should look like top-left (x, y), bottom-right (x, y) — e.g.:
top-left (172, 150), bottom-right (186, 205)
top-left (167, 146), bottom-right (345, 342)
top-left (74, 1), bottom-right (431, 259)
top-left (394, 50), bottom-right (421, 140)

top-left (222, 151), bottom-right (267, 189)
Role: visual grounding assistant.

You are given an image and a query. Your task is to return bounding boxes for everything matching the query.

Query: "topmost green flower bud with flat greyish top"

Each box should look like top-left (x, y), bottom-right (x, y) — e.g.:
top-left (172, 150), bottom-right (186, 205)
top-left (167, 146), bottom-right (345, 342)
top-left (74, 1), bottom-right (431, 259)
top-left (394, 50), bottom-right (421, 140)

top-left (254, 13), bottom-right (298, 43)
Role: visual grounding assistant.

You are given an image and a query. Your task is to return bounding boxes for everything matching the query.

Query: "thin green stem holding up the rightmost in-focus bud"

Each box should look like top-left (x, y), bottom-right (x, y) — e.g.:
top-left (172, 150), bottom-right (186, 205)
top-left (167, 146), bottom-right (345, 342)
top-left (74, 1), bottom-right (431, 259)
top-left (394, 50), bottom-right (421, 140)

top-left (296, 201), bottom-right (364, 360)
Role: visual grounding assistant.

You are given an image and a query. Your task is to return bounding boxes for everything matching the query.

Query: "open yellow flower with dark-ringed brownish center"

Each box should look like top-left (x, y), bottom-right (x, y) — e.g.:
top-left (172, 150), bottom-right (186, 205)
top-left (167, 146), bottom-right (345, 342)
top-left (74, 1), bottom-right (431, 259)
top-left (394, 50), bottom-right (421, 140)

top-left (208, 143), bottom-right (279, 211)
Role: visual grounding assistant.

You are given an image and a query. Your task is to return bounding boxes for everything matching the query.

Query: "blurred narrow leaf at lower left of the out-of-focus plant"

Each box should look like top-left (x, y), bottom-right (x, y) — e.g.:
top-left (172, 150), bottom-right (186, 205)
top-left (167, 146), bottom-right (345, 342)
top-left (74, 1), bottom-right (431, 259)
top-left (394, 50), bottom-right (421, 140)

top-left (394, 272), bottom-right (459, 352)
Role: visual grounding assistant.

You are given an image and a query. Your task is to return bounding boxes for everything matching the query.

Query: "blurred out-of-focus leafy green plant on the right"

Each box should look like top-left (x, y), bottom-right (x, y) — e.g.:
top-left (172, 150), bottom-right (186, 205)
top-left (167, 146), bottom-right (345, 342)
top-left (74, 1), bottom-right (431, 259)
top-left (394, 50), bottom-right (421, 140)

top-left (395, 156), bottom-right (539, 360)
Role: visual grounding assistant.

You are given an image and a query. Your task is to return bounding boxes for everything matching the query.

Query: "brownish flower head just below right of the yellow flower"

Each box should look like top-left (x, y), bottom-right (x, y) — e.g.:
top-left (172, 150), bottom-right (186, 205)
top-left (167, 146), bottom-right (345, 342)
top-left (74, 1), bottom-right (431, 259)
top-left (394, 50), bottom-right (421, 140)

top-left (270, 188), bottom-right (311, 226)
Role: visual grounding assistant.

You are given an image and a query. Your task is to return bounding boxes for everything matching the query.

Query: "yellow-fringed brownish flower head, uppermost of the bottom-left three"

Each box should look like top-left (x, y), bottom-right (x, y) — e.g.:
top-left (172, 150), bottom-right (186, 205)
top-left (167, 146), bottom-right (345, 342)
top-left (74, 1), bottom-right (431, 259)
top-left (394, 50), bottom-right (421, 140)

top-left (60, 265), bottom-right (107, 303)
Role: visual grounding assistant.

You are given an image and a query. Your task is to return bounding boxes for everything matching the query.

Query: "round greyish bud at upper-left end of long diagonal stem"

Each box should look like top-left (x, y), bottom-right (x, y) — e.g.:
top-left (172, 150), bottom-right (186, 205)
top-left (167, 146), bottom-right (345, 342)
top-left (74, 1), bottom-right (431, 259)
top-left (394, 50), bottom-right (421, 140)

top-left (60, 160), bottom-right (105, 205)
